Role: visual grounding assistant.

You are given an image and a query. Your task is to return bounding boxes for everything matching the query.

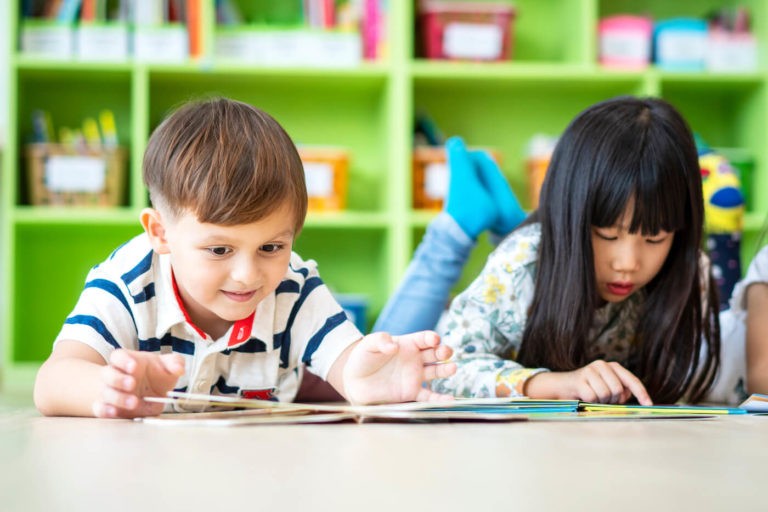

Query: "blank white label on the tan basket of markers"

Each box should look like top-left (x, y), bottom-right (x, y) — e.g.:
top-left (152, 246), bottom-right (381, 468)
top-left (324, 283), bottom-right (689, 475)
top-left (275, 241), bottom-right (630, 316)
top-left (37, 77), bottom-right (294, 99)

top-left (45, 156), bottom-right (107, 192)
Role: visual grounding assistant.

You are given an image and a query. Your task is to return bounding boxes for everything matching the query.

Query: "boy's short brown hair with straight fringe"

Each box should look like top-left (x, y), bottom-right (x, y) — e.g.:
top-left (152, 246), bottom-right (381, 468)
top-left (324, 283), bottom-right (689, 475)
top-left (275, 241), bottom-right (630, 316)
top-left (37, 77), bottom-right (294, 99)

top-left (143, 98), bottom-right (307, 234)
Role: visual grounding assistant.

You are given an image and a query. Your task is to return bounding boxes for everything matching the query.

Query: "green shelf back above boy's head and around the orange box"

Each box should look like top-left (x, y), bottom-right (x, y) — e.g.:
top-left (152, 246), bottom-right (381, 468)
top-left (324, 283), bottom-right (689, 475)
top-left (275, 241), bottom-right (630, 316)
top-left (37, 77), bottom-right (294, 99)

top-left (149, 69), bottom-right (391, 212)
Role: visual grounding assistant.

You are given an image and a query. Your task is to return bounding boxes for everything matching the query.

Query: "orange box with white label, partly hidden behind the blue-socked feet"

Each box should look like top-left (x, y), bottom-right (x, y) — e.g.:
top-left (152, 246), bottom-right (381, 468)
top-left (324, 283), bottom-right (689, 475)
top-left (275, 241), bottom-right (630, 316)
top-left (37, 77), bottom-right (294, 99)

top-left (413, 146), bottom-right (501, 210)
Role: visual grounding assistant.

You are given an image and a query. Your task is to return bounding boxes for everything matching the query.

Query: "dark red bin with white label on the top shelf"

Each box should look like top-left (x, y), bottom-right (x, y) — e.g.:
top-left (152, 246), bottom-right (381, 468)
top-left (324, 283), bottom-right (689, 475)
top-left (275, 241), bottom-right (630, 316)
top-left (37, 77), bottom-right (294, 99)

top-left (419, 0), bottom-right (515, 61)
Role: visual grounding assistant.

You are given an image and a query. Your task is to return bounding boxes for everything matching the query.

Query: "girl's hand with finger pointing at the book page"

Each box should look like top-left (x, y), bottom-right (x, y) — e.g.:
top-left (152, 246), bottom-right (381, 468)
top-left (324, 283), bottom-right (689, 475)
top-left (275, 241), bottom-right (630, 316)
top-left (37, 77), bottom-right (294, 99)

top-left (525, 359), bottom-right (653, 405)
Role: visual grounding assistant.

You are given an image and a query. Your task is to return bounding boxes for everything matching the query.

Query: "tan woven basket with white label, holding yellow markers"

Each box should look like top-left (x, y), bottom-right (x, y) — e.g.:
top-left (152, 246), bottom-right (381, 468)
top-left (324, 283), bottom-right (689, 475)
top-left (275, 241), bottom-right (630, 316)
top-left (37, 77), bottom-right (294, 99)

top-left (25, 143), bottom-right (127, 206)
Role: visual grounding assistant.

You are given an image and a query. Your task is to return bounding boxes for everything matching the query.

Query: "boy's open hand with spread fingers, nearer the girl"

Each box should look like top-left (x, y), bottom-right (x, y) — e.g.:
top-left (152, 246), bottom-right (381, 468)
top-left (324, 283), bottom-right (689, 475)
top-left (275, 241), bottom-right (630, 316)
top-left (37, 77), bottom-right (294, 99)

top-left (343, 331), bottom-right (456, 404)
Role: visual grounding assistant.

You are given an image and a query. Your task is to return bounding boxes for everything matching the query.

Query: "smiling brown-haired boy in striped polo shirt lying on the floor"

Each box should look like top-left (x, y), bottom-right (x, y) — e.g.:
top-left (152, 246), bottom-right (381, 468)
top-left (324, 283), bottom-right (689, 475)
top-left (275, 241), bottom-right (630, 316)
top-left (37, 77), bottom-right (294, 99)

top-left (35, 98), bottom-right (455, 418)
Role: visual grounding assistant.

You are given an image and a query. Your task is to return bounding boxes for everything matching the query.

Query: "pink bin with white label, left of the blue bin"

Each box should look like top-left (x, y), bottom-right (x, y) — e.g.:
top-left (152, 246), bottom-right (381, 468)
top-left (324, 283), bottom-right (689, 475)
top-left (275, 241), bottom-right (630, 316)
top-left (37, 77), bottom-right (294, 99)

top-left (597, 15), bottom-right (653, 69)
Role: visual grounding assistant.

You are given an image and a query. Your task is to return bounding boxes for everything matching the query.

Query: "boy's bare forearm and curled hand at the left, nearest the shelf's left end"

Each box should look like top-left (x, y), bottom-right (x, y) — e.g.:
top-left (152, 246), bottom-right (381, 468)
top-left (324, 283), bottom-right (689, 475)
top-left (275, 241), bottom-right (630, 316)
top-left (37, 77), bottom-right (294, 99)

top-left (34, 340), bottom-right (184, 418)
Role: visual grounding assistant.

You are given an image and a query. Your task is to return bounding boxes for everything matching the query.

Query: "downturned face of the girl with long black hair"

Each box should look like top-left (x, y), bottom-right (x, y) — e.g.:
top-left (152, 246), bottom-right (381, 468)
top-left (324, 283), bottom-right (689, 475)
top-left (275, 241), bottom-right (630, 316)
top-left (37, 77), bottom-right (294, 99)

top-left (592, 200), bottom-right (675, 302)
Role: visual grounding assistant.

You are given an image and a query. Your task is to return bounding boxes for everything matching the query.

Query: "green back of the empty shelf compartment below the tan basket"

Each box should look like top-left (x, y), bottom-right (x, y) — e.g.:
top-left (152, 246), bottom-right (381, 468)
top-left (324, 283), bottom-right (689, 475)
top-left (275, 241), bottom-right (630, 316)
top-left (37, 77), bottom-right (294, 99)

top-left (9, 222), bottom-right (141, 362)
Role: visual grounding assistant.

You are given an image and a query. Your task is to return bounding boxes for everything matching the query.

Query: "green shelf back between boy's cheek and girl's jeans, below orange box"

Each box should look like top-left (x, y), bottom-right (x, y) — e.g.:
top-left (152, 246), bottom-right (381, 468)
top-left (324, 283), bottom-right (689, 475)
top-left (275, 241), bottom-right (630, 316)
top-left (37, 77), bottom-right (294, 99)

top-left (294, 227), bottom-right (394, 325)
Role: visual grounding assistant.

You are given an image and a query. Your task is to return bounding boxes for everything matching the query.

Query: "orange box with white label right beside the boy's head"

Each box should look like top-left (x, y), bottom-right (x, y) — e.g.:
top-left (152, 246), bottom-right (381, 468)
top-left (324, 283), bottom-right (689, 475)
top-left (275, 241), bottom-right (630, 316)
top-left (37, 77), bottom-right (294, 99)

top-left (298, 147), bottom-right (349, 211)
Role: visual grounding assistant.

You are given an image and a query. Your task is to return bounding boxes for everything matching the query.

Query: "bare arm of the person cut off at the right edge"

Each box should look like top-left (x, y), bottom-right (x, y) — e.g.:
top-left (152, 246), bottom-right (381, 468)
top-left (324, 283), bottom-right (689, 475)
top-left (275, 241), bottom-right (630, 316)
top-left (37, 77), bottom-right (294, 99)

top-left (746, 283), bottom-right (768, 393)
